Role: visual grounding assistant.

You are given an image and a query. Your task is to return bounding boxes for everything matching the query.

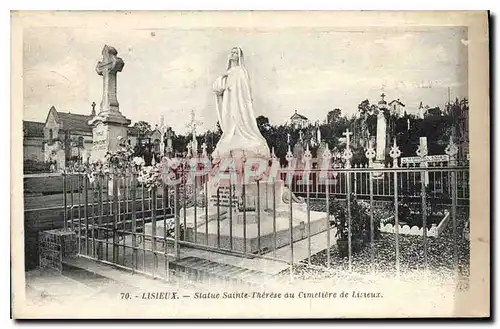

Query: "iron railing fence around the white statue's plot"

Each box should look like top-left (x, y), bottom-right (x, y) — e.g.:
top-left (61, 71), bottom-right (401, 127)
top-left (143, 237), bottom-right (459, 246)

top-left (63, 166), bottom-right (469, 280)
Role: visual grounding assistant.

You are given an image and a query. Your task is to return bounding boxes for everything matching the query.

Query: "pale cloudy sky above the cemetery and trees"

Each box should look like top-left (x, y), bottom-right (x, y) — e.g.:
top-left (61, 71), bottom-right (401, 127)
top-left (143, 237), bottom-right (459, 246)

top-left (23, 27), bottom-right (468, 133)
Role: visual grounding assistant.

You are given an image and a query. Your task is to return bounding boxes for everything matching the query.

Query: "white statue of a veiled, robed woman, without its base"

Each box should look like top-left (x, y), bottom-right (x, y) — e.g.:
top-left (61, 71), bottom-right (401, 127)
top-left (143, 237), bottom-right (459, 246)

top-left (212, 47), bottom-right (270, 159)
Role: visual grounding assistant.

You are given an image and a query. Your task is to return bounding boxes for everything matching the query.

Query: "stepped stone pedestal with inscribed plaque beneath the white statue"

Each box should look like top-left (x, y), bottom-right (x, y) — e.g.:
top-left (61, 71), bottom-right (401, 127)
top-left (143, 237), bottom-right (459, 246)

top-left (146, 176), bottom-right (329, 253)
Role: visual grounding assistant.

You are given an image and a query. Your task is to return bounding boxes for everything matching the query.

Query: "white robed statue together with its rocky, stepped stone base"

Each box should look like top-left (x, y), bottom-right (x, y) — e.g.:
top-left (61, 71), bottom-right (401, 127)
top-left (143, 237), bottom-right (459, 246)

top-left (146, 47), bottom-right (327, 253)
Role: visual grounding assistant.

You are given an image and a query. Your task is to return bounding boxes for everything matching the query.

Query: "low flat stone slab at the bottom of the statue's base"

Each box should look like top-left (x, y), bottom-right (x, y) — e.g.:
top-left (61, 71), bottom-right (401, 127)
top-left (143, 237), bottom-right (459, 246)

top-left (180, 203), bottom-right (329, 254)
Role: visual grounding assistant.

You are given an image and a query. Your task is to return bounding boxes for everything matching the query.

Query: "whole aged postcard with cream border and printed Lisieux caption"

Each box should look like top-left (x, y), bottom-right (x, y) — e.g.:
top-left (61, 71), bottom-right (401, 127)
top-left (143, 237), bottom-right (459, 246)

top-left (11, 11), bottom-right (490, 319)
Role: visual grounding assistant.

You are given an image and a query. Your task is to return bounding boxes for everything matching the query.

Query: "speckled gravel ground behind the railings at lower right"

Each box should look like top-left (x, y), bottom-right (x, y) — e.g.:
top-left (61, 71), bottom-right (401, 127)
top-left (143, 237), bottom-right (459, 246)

top-left (282, 201), bottom-right (470, 289)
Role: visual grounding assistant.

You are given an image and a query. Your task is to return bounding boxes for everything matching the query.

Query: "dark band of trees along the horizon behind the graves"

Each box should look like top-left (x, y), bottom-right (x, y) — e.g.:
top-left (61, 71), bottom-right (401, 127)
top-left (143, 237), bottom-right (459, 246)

top-left (126, 99), bottom-right (468, 165)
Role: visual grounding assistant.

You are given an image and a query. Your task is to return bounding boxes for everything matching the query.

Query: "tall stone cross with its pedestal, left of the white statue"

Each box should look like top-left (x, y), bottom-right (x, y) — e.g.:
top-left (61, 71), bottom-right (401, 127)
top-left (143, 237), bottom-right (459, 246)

top-left (88, 45), bottom-right (130, 161)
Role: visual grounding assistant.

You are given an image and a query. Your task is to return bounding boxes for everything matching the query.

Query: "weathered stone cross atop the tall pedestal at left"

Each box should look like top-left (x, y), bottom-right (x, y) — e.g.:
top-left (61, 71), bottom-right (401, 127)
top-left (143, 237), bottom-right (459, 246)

top-left (96, 45), bottom-right (125, 112)
